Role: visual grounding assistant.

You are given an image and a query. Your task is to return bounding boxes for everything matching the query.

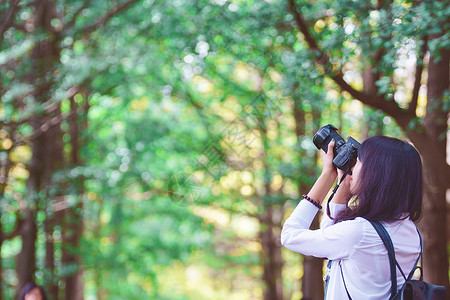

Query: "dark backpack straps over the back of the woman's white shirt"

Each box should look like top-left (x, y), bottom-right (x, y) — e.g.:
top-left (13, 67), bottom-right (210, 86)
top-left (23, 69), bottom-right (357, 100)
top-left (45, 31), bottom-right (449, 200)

top-left (369, 221), bottom-right (423, 299)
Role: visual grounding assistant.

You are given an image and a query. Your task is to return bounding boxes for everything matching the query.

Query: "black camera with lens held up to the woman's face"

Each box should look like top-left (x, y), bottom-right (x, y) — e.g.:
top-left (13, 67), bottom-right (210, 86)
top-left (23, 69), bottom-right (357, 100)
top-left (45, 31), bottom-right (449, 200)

top-left (313, 124), bottom-right (360, 171)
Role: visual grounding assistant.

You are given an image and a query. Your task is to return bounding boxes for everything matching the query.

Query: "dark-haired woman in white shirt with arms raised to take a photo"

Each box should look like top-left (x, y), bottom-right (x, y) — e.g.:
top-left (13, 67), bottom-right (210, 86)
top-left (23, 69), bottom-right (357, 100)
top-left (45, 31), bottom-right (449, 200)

top-left (281, 136), bottom-right (422, 300)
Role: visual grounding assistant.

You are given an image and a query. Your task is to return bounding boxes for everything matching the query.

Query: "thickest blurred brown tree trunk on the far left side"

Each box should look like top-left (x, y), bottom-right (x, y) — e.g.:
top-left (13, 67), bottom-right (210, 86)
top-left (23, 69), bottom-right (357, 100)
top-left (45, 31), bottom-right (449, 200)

top-left (17, 0), bottom-right (63, 299)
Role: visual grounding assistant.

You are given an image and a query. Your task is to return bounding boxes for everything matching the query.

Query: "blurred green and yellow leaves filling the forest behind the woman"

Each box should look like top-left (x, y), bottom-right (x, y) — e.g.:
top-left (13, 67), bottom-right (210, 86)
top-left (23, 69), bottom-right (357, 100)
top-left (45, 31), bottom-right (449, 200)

top-left (0, 0), bottom-right (436, 299)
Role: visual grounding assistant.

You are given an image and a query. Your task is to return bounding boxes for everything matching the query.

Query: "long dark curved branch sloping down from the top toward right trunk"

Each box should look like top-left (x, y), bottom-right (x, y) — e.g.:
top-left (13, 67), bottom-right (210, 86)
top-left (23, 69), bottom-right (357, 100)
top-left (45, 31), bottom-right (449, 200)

top-left (288, 0), bottom-right (411, 127)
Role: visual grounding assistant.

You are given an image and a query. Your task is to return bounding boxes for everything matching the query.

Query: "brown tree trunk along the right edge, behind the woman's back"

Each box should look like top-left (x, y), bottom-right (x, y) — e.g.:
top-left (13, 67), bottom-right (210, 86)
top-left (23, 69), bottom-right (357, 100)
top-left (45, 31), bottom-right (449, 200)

top-left (408, 51), bottom-right (450, 291)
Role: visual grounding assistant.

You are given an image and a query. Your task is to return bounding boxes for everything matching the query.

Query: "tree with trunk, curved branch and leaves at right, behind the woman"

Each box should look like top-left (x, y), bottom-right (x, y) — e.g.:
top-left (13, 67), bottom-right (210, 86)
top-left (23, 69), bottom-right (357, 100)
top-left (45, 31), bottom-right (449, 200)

top-left (288, 0), bottom-right (450, 289)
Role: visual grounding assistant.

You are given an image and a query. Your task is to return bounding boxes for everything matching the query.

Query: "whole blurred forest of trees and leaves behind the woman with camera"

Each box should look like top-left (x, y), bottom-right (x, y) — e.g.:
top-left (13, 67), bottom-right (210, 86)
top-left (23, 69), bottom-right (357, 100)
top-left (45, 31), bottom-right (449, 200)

top-left (0, 0), bottom-right (450, 300)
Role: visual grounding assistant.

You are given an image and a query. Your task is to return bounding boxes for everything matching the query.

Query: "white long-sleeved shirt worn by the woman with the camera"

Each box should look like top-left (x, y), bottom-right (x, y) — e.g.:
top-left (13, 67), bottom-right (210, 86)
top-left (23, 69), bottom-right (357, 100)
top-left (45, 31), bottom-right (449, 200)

top-left (281, 201), bottom-right (420, 300)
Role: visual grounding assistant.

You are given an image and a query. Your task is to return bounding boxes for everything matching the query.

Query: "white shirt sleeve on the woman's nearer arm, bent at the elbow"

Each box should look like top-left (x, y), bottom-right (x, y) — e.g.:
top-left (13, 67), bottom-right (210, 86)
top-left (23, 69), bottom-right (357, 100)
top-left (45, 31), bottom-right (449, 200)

top-left (281, 201), bottom-right (364, 259)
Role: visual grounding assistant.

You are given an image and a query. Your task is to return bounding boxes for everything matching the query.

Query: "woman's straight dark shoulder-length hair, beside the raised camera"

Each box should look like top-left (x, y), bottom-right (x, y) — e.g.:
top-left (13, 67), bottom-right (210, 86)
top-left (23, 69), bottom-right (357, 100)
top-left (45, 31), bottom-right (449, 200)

top-left (336, 136), bottom-right (422, 222)
